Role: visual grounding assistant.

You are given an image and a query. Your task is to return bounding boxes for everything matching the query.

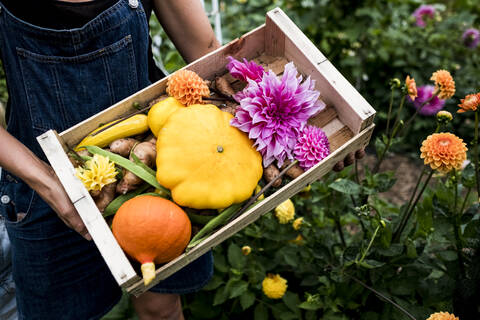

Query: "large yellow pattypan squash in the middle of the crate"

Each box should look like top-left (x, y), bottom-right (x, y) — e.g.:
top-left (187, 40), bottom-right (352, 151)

top-left (157, 104), bottom-right (263, 209)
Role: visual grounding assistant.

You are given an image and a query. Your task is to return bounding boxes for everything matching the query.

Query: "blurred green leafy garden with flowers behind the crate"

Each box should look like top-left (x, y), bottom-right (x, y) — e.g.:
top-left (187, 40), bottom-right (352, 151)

top-left (0, 0), bottom-right (480, 320)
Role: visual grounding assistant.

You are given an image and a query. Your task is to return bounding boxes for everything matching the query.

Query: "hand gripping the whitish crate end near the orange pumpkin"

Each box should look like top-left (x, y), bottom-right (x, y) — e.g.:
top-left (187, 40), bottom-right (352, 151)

top-left (33, 164), bottom-right (92, 240)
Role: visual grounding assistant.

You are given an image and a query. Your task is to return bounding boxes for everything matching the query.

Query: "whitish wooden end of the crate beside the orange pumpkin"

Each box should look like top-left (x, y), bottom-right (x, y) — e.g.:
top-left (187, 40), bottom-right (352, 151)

top-left (37, 130), bottom-right (138, 285)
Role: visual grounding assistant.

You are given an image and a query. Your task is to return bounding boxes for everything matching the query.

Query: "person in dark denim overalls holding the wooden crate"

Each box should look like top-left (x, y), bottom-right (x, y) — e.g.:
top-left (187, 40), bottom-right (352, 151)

top-left (0, 0), bottom-right (219, 320)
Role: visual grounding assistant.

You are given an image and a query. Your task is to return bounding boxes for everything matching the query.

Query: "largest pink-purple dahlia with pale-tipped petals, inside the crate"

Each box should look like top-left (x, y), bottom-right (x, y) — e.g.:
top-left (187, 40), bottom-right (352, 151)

top-left (230, 62), bottom-right (325, 167)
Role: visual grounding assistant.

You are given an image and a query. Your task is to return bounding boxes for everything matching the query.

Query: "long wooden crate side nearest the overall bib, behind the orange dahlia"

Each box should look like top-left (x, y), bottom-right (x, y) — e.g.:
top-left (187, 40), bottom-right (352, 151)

top-left (60, 25), bottom-right (265, 147)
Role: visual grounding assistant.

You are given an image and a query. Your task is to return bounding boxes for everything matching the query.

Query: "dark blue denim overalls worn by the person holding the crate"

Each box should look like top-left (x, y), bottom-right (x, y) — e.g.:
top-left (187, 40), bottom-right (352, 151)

top-left (0, 0), bottom-right (213, 320)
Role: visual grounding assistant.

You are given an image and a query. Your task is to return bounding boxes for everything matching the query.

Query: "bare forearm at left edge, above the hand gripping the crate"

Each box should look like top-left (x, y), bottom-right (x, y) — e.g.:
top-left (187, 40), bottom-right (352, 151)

top-left (0, 128), bottom-right (54, 190)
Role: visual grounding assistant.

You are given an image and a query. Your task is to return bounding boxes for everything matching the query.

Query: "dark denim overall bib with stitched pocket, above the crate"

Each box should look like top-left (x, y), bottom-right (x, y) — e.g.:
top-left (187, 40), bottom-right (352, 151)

top-left (0, 0), bottom-right (149, 159)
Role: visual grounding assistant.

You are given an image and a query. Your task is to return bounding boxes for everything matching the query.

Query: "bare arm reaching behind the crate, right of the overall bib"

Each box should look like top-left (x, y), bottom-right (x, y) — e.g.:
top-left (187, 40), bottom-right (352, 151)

top-left (154, 0), bottom-right (220, 63)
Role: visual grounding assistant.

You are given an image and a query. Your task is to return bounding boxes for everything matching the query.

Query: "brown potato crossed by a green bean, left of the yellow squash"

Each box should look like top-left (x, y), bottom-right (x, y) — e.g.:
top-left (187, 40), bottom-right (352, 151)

top-left (117, 142), bottom-right (157, 194)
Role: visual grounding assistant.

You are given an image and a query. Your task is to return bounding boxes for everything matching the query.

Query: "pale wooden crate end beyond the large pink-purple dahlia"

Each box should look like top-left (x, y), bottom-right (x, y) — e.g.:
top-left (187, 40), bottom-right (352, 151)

top-left (265, 8), bottom-right (375, 134)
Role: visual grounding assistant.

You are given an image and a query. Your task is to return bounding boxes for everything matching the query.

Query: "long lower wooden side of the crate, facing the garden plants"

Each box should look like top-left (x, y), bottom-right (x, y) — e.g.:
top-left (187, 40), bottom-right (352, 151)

top-left (126, 124), bottom-right (374, 296)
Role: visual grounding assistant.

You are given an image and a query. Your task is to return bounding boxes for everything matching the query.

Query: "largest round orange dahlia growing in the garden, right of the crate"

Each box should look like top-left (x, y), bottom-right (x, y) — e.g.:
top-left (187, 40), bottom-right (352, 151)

top-left (420, 132), bottom-right (467, 173)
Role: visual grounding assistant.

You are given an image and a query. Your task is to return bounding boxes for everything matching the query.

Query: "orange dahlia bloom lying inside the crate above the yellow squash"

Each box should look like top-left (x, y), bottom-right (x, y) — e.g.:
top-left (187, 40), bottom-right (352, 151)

top-left (167, 69), bottom-right (210, 106)
